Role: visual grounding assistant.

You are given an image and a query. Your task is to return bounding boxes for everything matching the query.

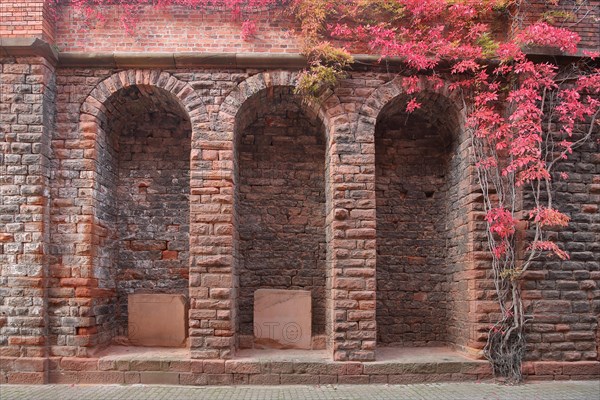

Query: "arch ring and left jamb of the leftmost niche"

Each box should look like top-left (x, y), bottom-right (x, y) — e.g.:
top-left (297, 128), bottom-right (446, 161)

top-left (67, 69), bottom-right (208, 354)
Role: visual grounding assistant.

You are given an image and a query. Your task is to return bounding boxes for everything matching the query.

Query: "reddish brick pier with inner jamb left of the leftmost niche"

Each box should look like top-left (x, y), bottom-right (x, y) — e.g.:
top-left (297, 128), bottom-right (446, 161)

top-left (49, 78), bottom-right (115, 357)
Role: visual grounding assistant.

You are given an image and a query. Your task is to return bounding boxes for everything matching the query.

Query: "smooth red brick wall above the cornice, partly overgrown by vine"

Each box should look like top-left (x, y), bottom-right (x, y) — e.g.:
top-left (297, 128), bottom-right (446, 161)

top-left (48, 0), bottom-right (600, 53)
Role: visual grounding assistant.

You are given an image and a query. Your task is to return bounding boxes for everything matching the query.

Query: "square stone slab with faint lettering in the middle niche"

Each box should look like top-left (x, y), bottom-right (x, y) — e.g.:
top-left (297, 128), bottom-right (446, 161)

top-left (254, 289), bottom-right (312, 349)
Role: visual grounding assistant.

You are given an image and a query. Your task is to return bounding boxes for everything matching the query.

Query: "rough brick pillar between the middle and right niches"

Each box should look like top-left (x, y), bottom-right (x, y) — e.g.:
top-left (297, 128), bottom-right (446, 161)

top-left (326, 101), bottom-right (376, 361)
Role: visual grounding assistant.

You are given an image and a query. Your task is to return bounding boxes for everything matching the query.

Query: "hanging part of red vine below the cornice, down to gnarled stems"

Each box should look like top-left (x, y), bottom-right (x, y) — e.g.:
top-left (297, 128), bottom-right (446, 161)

top-left (465, 45), bottom-right (600, 381)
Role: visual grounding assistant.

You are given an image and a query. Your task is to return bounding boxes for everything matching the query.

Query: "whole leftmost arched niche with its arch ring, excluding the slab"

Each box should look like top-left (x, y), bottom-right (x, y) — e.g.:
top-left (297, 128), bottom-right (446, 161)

top-left (69, 70), bottom-right (207, 354)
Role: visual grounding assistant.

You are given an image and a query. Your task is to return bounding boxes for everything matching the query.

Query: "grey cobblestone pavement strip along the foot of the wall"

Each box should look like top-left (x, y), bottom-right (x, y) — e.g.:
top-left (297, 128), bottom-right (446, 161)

top-left (0, 381), bottom-right (600, 400)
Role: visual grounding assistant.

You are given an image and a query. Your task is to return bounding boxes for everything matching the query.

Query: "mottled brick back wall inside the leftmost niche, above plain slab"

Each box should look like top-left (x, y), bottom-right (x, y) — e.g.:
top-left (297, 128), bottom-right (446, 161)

top-left (102, 86), bottom-right (191, 335)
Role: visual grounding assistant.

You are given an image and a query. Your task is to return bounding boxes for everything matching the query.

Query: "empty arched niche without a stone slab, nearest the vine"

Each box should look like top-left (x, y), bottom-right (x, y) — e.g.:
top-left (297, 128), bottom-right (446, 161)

top-left (356, 77), bottom-right (483, 349)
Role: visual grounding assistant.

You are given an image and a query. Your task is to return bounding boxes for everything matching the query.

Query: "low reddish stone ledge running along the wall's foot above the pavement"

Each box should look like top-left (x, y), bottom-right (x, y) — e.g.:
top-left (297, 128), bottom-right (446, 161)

top-left (5, 357), bottom-right (600, 385)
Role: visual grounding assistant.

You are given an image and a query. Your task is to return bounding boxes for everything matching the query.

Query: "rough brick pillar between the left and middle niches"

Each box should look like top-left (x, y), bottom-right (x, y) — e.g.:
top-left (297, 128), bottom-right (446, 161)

top-left (189, 140), bottom-right (236, 359)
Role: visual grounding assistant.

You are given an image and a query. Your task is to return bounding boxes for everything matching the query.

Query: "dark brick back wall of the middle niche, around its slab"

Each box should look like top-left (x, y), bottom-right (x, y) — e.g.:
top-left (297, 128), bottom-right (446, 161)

top-left (237, 87), bottom-right (326, 334)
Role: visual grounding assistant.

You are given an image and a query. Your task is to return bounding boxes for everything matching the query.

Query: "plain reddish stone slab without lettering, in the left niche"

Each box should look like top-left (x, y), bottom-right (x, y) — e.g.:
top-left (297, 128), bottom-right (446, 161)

top-left (128, 294), bottom-right (187, 347)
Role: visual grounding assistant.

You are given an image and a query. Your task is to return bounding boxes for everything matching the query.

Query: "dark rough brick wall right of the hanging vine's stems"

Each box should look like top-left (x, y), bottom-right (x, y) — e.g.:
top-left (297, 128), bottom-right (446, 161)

top-left (523, 126), bottom-right (600, 361)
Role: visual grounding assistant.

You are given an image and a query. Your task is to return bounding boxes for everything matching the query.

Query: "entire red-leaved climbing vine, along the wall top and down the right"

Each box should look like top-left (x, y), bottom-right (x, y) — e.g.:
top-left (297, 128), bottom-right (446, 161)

top-left (52, 0), bottom-right (600, 382)
